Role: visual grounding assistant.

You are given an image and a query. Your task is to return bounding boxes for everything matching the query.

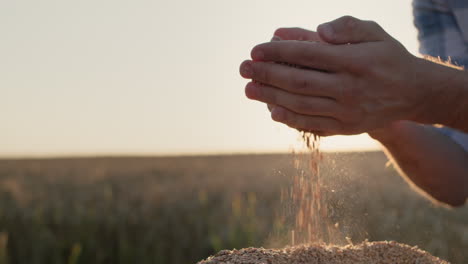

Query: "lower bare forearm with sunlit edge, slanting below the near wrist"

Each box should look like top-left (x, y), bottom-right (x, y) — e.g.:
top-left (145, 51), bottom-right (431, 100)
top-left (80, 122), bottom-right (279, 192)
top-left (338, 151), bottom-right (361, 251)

top-left (369, 121), bottom-right (468, 206)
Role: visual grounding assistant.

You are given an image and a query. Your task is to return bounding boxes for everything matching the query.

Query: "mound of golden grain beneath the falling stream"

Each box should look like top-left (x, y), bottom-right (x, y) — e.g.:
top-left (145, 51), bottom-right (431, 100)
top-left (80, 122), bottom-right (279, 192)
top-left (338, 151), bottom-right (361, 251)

top-left (198, 241), bottom-right (448, 264)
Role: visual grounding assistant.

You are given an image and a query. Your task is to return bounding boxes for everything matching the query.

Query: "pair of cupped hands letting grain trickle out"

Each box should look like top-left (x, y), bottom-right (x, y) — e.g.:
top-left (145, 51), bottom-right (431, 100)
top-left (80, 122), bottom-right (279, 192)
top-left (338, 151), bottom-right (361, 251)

top-left (240, 16), bottom-right (427, 136)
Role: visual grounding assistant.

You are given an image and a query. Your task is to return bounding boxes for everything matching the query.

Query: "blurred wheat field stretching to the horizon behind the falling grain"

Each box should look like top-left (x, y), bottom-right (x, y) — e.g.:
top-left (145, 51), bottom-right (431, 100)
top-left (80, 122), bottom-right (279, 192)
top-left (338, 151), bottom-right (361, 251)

top-left (0, 152), bottom-right (468, 264)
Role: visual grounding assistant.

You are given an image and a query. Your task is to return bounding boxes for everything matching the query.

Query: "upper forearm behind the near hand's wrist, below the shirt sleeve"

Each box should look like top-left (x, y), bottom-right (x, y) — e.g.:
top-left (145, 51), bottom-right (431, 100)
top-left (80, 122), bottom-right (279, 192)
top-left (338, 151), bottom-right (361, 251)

top-left (411, 58), bottom-right (468, 133)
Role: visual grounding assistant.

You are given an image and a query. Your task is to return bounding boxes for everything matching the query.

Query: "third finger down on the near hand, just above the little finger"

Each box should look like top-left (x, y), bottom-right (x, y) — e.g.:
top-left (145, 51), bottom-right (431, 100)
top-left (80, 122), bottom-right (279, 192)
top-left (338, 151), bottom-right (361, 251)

top-left (245, 82), bottom-right (341, 117)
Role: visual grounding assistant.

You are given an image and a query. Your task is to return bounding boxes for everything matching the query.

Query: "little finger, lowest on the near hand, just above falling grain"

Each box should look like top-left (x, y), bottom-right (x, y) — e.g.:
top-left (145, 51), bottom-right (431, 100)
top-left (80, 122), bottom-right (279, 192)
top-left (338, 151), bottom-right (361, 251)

top-left (271, 106), bottom-right (341, 136)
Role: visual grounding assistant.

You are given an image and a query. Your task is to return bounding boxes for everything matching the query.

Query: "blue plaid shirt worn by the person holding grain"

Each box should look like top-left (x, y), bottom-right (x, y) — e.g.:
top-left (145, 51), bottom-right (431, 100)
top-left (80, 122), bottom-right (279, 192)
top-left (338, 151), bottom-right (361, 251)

top-left (413, 0), bottom-right (468, 151)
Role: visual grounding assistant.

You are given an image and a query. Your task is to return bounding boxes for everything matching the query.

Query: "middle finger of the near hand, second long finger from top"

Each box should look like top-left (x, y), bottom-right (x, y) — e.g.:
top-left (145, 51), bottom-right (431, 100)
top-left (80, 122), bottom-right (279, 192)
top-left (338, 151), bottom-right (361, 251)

top-left (241, 61), bottom-right (341, 99)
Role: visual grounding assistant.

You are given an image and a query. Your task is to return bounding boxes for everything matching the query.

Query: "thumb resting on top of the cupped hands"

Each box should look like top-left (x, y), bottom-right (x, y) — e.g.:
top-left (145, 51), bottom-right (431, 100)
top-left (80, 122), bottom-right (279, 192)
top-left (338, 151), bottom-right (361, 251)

top-left (317, 16), bottom-right (391, 44)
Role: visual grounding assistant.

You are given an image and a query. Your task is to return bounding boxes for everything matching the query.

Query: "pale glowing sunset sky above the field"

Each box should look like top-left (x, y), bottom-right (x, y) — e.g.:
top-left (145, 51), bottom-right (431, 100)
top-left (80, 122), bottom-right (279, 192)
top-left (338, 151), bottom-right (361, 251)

top-left (0, 0), bottom-right (418, 157)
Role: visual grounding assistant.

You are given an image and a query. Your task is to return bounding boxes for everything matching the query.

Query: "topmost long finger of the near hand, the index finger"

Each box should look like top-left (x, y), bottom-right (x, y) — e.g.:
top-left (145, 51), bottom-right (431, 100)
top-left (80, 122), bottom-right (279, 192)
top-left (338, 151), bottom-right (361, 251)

top-left (251, 40), bottom-right (342, 71)
